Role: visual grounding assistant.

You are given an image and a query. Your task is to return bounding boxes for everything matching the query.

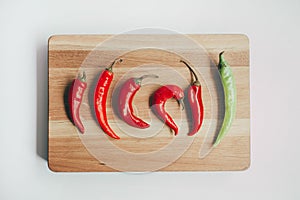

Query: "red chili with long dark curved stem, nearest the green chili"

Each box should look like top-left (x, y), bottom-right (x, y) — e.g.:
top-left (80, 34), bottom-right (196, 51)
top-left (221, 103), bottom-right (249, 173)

top-left (180, 60), bottom-right (204, 136)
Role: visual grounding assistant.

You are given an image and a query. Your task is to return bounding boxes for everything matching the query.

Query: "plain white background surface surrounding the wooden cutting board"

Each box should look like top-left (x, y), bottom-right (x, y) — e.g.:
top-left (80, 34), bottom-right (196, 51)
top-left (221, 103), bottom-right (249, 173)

top-left (0, 0), bottom-right (300, 200)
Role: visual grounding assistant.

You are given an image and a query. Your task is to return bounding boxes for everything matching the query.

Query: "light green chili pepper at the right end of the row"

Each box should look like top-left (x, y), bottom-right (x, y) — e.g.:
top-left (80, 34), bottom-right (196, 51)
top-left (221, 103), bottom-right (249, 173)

top-left (214, 51), bottom-right (237, 147)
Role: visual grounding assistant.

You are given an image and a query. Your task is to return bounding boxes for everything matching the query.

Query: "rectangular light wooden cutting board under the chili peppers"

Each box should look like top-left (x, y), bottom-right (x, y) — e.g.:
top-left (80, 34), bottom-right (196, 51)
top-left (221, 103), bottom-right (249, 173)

top-left (48, 34), bottom-right (250, 172)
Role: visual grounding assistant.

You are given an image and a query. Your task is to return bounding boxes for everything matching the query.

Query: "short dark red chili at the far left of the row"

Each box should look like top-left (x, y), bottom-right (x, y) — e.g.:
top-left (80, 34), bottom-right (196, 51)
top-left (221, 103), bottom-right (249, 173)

top-left (68, 72), bottom-right (87, 133)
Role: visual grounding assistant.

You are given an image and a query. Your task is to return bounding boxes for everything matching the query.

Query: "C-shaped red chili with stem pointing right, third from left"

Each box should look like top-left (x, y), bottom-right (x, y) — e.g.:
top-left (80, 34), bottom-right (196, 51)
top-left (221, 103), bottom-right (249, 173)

top-left (118, 75), bottom-right (158, 129)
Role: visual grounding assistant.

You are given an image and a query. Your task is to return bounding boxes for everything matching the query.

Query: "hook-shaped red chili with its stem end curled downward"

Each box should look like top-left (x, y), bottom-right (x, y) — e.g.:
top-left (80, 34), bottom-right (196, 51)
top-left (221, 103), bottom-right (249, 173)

top-left (152, 85), bottom-right (184, 135)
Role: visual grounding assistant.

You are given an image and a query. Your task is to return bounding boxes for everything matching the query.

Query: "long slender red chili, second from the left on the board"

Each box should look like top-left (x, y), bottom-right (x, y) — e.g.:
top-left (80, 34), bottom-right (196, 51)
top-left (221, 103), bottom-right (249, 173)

top-left (94, 59), bottom-right (122, 139)
